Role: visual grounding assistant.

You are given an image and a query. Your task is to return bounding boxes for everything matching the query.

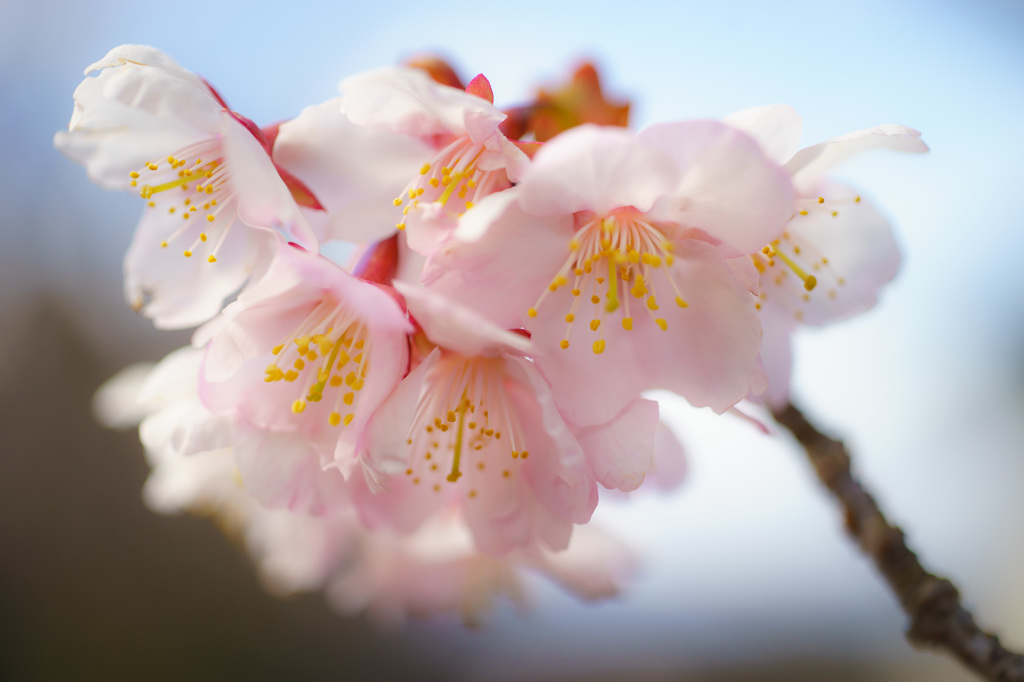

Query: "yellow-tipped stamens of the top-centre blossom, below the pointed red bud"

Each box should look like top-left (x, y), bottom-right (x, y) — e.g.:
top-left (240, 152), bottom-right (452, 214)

top-left (393, 136), bottom-right (508, 229)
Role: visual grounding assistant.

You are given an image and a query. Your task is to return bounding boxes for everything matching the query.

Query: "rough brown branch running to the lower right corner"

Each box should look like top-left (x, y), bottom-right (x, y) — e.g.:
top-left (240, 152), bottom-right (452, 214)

top-left (774, 404), bottom-right (1024, 682)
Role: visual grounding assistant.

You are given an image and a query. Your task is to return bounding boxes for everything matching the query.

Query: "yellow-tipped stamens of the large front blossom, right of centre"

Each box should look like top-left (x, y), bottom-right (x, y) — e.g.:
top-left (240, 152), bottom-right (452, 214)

top-left (527, 211), bottom-right (689, 354)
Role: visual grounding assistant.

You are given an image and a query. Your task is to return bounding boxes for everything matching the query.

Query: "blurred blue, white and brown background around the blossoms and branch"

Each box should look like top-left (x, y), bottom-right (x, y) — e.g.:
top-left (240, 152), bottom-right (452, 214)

top-left (0, 0), bottom-right (1024, 681)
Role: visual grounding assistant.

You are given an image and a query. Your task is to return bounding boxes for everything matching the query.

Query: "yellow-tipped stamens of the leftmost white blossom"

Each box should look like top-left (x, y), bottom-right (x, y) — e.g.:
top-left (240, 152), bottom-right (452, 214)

top-left (130, 139), bottom-right (233, 263)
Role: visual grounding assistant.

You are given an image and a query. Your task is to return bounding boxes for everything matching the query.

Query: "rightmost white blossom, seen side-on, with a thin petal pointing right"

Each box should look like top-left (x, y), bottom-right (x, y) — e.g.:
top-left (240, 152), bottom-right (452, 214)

top-left (725, 105), bottom-right (928, 406)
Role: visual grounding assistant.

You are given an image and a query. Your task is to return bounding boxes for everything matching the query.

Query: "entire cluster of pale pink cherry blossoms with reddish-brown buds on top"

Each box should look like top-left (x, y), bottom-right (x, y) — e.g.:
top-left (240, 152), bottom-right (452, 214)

top-left (55, 45), bottom-right (927, 619)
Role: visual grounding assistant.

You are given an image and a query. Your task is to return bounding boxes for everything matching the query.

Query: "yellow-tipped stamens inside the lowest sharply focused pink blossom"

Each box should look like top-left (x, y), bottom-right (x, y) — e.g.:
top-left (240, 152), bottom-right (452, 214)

top-left (406, 353), bottom-right (529, 499)
